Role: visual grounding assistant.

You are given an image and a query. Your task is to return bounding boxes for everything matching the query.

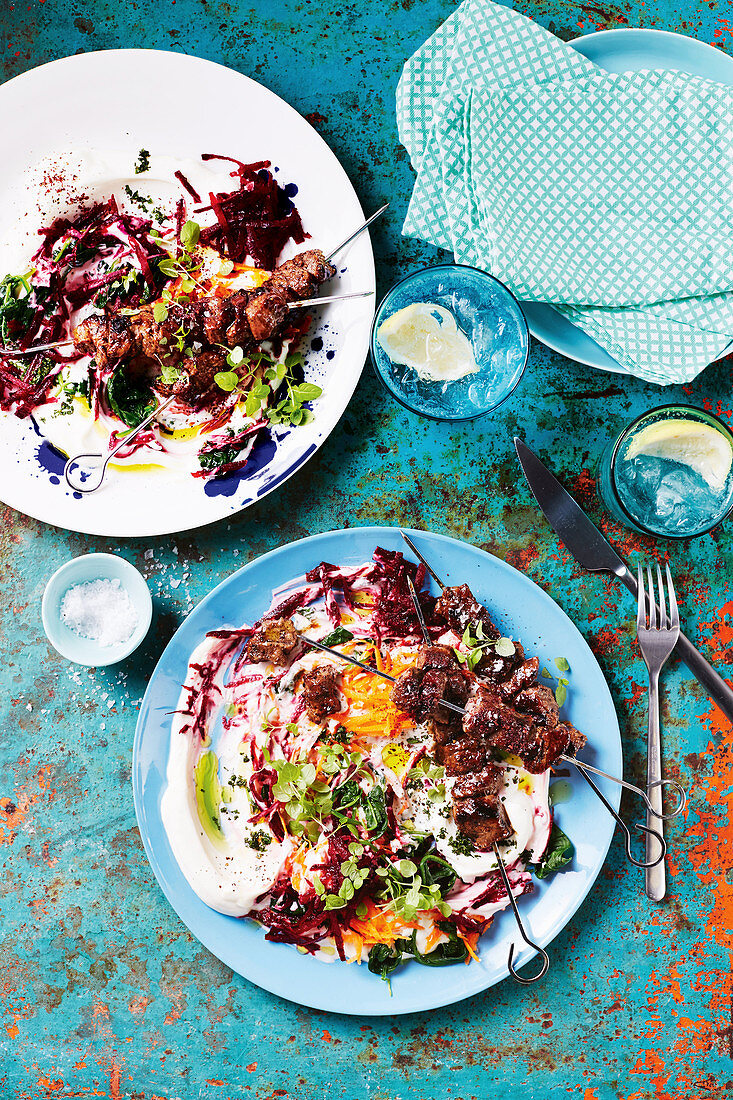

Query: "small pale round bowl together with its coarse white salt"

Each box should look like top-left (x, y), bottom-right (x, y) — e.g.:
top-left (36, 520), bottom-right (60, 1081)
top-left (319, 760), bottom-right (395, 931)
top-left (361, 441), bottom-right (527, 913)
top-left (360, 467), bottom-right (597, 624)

top-left (41, 553), bottom-right (153, 668)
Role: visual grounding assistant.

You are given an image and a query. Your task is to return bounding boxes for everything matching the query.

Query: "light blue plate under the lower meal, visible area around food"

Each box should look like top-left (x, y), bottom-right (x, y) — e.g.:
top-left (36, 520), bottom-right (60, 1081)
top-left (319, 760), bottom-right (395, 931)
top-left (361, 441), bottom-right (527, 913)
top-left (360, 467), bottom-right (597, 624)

top-left (132, 527), bottom-right (623, 1015)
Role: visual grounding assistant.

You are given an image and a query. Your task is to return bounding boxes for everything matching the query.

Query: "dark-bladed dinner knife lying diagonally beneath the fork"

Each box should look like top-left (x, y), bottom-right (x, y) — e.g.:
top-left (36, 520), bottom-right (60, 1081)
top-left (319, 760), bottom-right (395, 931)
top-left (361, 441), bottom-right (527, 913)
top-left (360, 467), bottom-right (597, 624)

top-left (514, 436), bottom-right (733, 724)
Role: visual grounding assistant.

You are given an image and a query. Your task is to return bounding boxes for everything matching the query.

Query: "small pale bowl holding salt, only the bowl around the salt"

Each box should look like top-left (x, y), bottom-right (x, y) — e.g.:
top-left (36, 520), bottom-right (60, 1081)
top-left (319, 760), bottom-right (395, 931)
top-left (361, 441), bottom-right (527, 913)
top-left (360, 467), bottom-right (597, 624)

top-left (41, 553), bottom-right (153, 668)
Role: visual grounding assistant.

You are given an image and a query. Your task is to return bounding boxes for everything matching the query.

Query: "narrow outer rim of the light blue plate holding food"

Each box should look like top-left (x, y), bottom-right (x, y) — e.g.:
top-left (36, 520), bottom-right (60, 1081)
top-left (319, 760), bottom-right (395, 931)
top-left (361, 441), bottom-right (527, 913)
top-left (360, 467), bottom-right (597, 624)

top-left (132, 525), bottom-right (623, 1016)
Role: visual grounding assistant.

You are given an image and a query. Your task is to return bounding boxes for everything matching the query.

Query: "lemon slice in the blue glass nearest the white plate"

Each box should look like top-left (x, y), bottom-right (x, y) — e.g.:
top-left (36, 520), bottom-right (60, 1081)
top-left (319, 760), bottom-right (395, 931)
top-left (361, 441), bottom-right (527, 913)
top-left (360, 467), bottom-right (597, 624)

top-left (376, 301), bottom-right (480, 382)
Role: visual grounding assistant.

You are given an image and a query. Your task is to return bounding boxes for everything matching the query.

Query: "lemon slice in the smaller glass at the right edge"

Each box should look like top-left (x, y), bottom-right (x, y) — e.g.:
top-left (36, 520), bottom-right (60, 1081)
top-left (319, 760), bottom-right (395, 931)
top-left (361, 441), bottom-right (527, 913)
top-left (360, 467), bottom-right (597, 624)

top-left (625, 419), bottom-right (733, 492)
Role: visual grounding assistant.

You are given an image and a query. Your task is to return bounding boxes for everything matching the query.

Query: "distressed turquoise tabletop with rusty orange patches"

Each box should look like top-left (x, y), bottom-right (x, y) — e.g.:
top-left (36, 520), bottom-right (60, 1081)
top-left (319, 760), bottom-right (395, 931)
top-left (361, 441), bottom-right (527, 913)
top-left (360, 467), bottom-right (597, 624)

top-left (0, 0), bottom-right (733, 1100)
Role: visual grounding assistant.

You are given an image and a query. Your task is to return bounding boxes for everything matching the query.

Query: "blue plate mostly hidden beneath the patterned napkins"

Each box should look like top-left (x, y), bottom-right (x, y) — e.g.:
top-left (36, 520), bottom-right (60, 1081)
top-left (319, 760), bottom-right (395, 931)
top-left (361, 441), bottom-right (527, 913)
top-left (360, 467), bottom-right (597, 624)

top-left (522, 28), bottom-right (733, 374)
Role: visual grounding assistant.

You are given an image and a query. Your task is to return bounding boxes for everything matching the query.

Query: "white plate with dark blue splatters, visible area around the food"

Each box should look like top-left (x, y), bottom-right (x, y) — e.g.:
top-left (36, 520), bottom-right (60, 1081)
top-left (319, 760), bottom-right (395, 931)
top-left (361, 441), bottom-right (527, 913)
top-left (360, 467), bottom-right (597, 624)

top-left (0, 50), bottom-right (374, 538)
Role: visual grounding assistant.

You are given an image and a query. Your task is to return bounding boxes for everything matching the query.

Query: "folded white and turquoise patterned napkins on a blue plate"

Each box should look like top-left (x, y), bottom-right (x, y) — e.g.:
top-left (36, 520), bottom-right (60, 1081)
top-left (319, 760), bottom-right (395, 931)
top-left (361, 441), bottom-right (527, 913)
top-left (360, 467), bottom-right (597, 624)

top-left (397, 0), bottom-right (733, 385)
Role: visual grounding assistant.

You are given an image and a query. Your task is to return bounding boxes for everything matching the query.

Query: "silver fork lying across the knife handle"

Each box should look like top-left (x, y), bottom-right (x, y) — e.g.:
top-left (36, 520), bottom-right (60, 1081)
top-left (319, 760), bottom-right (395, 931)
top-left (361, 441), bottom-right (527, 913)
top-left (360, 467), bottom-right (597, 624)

top-left (636, 564), bottom-right (679, 901)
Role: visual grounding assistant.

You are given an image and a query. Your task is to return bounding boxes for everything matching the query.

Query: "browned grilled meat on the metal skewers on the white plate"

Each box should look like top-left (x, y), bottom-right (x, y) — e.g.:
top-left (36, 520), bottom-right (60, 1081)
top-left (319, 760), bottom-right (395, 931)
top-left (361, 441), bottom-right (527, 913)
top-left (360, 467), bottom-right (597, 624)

top-left (73, 249), bottom-right (336, 406)
